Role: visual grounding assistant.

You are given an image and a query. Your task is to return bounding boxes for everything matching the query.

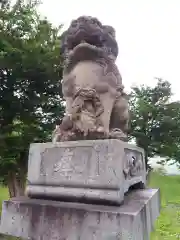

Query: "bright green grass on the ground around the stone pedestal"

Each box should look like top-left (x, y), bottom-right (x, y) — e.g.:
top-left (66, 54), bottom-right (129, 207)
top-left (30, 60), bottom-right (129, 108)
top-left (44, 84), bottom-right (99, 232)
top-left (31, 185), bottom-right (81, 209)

top-left (0, 173), bottom-right (180, 240)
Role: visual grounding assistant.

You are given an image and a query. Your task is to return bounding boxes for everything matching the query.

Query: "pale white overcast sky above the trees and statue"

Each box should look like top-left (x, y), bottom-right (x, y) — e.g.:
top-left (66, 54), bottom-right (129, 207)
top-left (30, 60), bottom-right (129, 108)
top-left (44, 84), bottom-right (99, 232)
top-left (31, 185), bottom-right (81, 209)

top-left (39, 0), bottom-right (180, 100)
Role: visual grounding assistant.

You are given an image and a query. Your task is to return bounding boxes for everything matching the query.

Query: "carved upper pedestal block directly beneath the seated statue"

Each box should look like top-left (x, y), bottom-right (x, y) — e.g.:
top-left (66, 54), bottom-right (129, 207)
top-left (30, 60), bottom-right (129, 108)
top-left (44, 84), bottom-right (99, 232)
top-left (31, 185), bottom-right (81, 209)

top-left (26, 139), bottom-right (146, 204)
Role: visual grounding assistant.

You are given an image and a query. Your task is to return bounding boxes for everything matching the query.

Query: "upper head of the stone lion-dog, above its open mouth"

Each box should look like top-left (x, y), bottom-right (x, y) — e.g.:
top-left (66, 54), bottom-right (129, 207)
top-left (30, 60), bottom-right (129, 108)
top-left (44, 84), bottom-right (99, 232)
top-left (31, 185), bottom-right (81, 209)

top-left (61, 16), bottom-right (118, 59)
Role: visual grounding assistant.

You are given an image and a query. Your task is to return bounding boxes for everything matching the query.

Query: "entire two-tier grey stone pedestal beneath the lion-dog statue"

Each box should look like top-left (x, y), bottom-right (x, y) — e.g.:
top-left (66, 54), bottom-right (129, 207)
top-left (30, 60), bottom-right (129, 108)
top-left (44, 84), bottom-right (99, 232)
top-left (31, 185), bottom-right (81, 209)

top-left (0, 139), bottom-right (160, 240)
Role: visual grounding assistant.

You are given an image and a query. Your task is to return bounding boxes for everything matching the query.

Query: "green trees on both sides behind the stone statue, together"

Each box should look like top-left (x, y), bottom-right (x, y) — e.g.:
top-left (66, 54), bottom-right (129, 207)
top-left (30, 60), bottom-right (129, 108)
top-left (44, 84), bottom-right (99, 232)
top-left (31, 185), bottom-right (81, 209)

top-left (0, 0), bottom-right (180, 197)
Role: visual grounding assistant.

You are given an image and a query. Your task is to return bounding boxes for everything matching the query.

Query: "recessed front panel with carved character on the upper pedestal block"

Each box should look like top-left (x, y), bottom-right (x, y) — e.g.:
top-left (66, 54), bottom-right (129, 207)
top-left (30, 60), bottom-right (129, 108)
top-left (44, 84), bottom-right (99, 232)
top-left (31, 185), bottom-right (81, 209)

top-left (40, 145), bottom-right (118, 184)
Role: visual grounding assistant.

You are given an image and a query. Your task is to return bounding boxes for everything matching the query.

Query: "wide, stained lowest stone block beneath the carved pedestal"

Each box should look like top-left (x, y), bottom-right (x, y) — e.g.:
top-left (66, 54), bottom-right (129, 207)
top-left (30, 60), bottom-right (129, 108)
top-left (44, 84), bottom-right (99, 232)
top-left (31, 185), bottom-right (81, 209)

top-left (0, 189), bottom-right (160, 240)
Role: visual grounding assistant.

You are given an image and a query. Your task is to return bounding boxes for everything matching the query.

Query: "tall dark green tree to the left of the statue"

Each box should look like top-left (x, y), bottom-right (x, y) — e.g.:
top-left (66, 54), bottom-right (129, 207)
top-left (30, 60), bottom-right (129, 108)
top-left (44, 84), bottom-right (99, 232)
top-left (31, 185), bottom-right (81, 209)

top-left (0, 0), bottom-right (64, 196)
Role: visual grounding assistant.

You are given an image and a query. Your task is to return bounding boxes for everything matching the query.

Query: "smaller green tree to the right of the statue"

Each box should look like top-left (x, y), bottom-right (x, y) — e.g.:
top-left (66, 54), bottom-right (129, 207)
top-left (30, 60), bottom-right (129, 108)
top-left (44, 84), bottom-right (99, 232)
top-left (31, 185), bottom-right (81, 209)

top-left (130, 79), bottom-right (180, 169)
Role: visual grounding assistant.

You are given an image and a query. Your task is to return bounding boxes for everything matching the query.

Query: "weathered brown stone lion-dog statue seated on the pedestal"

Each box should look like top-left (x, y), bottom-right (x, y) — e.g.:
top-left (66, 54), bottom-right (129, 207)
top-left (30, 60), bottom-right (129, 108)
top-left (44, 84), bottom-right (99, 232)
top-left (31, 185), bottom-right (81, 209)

top-left (53, 16), bottom-right (129, 142)
